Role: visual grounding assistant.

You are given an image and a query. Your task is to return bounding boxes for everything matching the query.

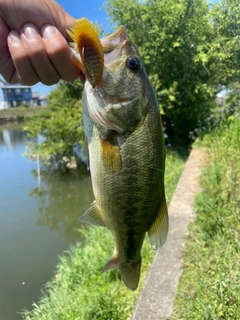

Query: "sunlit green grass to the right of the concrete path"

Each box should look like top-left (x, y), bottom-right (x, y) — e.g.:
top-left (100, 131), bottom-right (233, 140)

top-left (169, 119), bottom-right (240, 320)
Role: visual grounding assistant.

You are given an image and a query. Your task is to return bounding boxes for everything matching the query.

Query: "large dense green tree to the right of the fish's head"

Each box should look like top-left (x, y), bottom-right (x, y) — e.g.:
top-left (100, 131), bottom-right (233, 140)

top-left (106, 0), bottom-right (239, 140)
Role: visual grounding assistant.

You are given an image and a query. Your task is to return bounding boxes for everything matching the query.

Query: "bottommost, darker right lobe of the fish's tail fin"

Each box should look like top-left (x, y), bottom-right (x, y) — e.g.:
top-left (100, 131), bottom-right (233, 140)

top-left (119, 258), bottom-right (141, 290)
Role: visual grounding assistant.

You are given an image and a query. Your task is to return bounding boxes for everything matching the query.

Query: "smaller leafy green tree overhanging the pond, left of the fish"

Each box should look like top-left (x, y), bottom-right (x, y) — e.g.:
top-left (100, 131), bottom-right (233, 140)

top-left (24, 81), bottom-right (84, 168)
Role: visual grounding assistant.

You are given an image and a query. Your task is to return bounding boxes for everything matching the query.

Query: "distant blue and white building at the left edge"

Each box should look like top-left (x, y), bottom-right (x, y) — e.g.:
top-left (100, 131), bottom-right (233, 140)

top-left (0, 81), bottom-right (32, 109)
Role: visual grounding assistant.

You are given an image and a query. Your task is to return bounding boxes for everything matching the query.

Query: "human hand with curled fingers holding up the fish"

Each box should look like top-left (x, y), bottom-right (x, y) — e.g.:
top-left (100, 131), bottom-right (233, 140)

top-left (0, 0), bottom-right (82, 85)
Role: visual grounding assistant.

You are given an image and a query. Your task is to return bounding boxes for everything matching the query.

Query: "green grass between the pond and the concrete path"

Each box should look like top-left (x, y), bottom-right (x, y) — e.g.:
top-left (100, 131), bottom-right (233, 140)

top-left (23, 152), bottom-right (185, 320)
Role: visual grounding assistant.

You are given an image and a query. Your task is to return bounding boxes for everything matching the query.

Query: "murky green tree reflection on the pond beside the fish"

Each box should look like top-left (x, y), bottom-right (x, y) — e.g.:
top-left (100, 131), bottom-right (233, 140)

top-left (29, 170), bottom-right (93, 243)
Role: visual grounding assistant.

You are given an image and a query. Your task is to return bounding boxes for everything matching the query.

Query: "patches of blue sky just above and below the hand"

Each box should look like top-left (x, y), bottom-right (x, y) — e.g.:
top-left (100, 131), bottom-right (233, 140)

top-left (32, 0), bottom-right (111, 95)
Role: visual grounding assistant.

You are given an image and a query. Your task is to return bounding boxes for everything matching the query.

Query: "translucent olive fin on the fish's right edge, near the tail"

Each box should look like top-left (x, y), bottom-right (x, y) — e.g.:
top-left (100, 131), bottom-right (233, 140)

top-left (148, 194), bottom-right (168, 250)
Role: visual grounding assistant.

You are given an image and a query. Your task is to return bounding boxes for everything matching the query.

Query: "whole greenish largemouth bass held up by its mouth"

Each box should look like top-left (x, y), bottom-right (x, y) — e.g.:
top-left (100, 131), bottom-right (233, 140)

top-left (68, 18), bottom-right (168, 290)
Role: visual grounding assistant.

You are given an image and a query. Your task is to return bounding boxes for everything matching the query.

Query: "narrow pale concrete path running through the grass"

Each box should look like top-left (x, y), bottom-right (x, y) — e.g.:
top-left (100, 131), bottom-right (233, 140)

top-left (132, 149), bottom-right (206, 320)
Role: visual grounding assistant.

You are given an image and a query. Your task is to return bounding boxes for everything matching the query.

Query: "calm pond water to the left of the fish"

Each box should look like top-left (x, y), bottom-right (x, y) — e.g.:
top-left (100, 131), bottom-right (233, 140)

top-left (0, 124), bottom-right (93, 320)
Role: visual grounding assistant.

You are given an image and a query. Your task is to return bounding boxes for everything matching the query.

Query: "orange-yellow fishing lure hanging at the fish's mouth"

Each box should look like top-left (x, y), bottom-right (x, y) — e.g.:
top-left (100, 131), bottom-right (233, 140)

top-left (68, 18), bottom-right (104, 87)
